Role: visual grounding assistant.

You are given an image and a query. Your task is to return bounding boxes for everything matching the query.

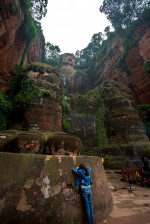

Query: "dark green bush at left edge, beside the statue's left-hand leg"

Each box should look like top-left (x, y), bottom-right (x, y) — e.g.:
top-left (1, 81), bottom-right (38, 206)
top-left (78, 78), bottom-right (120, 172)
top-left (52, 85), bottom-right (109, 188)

top-left (0, 92), bottom-right (12, 131)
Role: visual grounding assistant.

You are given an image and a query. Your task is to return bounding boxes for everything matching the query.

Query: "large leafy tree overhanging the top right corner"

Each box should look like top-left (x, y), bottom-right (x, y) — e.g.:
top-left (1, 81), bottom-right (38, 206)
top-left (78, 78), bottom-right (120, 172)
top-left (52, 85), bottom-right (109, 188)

top-left (100, 0), bottom-right (150, 30)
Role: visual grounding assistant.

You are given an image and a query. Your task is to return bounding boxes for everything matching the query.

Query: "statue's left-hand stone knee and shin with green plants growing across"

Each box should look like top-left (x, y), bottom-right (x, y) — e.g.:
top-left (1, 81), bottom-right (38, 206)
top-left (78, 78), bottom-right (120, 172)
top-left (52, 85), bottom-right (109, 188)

top-left (19, 63), bottom-right (62, 131)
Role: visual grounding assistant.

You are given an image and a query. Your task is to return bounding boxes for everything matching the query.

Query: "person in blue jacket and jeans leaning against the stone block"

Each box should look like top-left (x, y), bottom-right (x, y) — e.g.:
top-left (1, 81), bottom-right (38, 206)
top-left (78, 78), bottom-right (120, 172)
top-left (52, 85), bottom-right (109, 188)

top-left (72, 164), bottom-right (93, 224)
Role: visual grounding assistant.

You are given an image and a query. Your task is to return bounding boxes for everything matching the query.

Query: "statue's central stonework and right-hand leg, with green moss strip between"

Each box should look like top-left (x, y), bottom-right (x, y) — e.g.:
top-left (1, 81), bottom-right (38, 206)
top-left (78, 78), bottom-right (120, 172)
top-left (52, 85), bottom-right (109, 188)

top-left (65, 80), bottom-right (149, 154)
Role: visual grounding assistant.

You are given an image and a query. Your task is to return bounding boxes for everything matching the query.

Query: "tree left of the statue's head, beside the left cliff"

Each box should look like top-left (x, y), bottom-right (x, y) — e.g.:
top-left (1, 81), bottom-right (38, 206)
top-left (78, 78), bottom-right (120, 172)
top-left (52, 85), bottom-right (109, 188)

top-left (45, 42), bottom-right (61, 67)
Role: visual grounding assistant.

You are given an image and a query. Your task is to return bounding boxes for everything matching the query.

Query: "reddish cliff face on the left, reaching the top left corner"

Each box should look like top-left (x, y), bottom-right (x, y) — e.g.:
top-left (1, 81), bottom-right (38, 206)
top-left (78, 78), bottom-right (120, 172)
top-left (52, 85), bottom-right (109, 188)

top-left (0, 0), bottom-right (44, 93)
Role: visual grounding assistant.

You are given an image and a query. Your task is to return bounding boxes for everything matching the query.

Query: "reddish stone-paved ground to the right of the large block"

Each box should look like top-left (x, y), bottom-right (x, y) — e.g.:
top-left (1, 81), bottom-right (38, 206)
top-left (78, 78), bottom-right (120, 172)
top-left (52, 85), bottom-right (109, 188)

top-left (96, 170), bottom-right (150, 224)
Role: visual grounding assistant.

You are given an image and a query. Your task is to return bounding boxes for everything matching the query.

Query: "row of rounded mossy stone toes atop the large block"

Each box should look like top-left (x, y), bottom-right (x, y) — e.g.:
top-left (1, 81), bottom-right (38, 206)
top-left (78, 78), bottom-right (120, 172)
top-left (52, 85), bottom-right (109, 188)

top-left (0, 129), bottom-right (82, 156)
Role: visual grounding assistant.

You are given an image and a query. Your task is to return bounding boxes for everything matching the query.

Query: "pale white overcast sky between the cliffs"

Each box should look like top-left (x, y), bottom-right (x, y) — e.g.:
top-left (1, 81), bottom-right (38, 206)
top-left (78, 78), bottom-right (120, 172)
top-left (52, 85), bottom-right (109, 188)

top-left (41, 0), bottom-right (110, 53)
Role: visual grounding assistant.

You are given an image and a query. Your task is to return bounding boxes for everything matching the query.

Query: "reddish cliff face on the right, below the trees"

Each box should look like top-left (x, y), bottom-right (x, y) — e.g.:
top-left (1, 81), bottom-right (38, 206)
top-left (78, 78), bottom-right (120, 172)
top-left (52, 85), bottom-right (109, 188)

top-left (93, 21), bottom-right (150, 104)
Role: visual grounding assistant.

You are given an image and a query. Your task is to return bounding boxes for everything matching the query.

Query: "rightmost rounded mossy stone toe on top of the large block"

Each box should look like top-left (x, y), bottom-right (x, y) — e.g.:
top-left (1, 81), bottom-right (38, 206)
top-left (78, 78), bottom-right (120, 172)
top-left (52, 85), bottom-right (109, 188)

top-left (45, 132), bottom-right (82, 155)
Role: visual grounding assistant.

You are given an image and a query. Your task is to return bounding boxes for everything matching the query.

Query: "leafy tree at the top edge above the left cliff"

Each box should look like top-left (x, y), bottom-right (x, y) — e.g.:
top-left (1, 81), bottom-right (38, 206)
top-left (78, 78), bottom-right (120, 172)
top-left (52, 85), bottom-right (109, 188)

top-left (31, 0), bottom-right (48, 20)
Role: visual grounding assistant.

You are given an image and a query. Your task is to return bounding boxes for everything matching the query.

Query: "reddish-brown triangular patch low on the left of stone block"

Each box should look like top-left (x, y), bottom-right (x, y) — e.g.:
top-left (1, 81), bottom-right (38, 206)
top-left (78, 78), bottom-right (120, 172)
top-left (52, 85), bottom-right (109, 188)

top-left (16, 190), bottom-right (31, 212)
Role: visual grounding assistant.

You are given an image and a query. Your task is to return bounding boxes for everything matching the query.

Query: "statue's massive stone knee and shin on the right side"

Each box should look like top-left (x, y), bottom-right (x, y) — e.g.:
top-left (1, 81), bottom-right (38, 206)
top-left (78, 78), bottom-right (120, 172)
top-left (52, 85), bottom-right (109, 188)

top-left (102, 81), bottom-right (149, 144)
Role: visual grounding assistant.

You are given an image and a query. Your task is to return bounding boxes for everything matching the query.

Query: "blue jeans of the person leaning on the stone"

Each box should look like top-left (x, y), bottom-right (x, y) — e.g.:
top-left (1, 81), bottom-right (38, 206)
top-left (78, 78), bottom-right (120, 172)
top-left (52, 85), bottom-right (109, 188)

top-left (81, 188), bottom-right (93, 224)
